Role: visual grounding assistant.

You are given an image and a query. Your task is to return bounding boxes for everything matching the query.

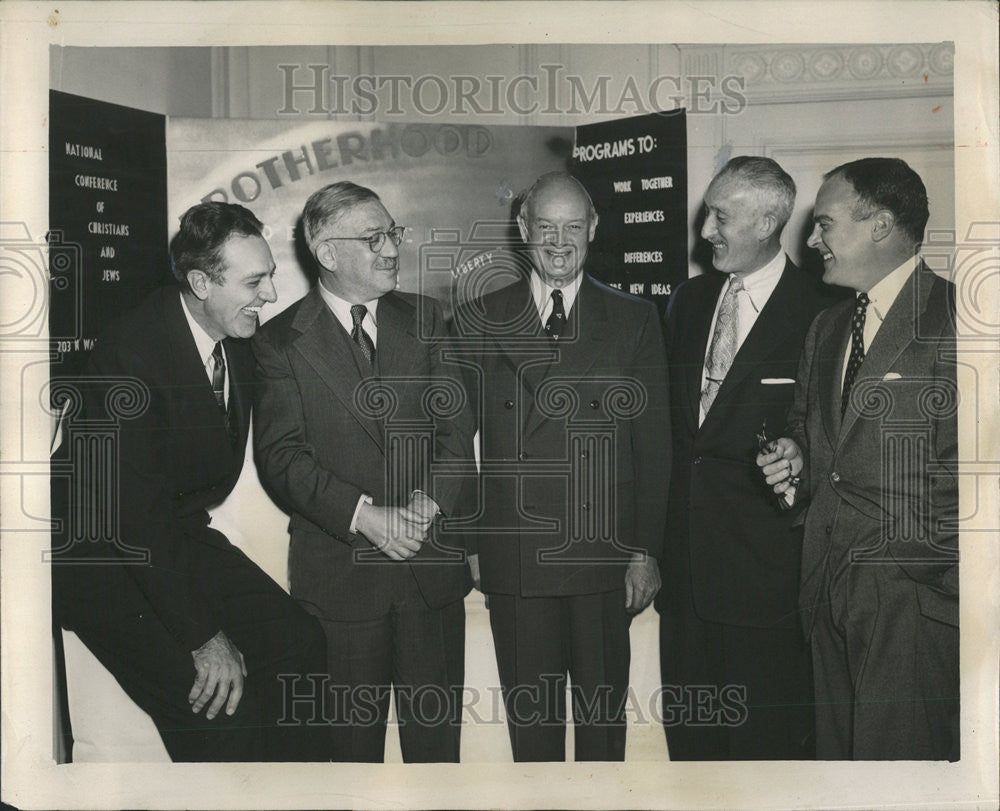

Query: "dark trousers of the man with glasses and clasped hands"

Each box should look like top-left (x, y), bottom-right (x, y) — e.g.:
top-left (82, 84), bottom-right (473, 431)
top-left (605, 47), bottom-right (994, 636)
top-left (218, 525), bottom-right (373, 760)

top-left (321, 566), bottom-right (465, 763)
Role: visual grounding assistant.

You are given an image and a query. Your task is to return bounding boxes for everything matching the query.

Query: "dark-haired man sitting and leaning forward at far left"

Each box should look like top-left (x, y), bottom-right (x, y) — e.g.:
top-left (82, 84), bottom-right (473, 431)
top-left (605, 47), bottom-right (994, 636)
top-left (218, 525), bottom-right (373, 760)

top-left (53, 203), bottom-right (329, 761)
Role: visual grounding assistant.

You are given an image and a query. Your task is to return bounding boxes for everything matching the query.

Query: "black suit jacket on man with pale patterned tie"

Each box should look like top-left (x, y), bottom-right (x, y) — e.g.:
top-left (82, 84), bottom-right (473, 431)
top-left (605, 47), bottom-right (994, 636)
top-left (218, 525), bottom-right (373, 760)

top-left (658, 259), bottom-right (823, 628)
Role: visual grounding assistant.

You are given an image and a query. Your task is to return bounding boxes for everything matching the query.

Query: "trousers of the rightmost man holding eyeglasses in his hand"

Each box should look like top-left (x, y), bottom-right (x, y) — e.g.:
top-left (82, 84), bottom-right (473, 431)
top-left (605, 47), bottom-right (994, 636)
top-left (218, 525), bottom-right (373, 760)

top-left (811, 562), bottom-right (960, 761)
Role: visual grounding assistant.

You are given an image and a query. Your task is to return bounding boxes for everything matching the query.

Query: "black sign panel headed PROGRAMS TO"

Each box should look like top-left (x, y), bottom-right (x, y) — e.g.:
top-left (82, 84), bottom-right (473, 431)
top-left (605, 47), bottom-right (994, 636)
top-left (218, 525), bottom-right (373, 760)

top-left (573, 110), bottom-right (688, 315)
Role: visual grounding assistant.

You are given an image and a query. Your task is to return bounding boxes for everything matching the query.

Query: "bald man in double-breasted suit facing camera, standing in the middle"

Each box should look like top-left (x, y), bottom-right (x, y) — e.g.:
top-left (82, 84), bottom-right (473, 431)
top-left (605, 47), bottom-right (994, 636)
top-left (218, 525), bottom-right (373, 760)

top-left (455, 173), bottom-right (670, 761)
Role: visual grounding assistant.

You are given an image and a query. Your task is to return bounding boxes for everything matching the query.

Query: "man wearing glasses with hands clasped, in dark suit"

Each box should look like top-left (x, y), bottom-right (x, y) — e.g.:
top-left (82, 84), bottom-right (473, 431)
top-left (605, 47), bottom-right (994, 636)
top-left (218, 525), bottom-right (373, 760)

top-left (253, 182), bottom-right (471, 762)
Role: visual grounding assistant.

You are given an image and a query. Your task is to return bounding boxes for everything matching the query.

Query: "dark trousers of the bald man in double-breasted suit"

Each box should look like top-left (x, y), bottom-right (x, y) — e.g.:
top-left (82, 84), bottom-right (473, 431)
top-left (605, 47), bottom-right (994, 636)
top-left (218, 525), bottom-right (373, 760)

top-left (490, 590), bottom-right (630, 762)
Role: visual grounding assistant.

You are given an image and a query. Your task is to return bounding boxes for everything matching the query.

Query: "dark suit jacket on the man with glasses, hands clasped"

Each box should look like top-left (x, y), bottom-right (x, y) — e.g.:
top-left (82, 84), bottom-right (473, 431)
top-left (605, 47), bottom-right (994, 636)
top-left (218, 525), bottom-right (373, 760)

top-left (252, 288), bottom-right (471, 620)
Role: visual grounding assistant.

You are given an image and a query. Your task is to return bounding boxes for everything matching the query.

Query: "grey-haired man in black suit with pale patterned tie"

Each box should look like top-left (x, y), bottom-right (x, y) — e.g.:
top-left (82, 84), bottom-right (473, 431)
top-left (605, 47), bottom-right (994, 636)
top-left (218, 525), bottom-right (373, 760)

top-left (657, 157), bottom-right (822, 760)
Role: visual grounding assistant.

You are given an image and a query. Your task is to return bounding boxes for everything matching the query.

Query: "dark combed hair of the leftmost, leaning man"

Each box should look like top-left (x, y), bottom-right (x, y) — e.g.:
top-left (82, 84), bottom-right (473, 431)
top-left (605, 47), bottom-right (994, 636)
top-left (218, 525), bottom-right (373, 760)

top-left (170, 201), bottom-right (264, 285)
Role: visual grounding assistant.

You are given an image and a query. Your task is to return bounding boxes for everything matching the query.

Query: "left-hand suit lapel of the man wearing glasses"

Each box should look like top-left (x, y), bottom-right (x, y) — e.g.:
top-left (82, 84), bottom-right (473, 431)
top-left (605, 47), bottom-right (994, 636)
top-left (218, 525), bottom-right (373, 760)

top-left (292, 287), bottom-right (384, 452)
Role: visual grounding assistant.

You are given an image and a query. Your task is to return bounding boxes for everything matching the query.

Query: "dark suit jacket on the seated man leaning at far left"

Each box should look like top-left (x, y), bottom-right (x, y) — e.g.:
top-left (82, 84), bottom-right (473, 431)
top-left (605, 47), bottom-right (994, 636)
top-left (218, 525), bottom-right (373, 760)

top-left (54, 286), bottom-right (253, 650)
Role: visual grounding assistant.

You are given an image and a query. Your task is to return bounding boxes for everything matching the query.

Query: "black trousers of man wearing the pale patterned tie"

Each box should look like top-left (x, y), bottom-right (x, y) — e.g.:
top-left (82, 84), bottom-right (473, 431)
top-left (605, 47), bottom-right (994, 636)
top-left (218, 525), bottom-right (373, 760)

top-left (660, 594), bottom-right (813, 760)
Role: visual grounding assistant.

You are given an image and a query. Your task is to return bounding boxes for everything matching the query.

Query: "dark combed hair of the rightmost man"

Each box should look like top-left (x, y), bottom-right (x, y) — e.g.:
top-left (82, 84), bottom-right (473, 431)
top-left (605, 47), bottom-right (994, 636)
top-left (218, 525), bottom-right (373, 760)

top-left (823, 158), bottom-right (930, 246)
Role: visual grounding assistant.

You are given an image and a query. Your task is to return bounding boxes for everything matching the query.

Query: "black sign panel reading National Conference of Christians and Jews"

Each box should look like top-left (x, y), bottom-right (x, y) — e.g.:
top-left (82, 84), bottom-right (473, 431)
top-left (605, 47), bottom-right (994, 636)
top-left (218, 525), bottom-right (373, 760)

top-left (49, 91), bottom-right (170, 377)
